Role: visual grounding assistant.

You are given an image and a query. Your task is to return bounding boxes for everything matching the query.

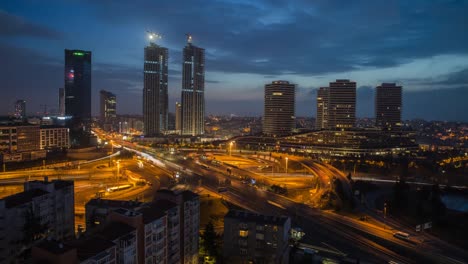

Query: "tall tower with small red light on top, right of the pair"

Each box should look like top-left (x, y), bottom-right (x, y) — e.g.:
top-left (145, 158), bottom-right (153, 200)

top-left (181, 35), bottom-right (205, 136)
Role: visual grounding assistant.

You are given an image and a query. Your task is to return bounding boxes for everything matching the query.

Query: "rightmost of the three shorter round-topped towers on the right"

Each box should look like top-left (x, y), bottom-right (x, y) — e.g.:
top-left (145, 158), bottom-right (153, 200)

top-left (375, 83), bottom-right (402, 131)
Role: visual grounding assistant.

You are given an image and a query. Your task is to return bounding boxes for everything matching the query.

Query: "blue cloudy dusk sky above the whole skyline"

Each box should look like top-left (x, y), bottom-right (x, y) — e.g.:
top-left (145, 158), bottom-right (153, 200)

top-left (0, 0), bottom-right (468, 121)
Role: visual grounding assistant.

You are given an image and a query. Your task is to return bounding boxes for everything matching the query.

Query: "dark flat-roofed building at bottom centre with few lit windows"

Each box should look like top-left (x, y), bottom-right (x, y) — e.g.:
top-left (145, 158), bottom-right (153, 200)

top-left (223, 210), bottom-right (291, 264)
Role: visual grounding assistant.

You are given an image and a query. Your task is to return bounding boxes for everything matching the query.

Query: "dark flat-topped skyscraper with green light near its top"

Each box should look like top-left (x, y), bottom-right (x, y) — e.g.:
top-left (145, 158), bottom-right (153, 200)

top-left (64, 49), bottom-right (91, 122)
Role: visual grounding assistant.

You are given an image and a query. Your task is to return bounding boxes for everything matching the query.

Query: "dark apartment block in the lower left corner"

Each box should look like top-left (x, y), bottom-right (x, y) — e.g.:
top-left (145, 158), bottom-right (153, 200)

top-left (0, 179), bottom-right (75, 263)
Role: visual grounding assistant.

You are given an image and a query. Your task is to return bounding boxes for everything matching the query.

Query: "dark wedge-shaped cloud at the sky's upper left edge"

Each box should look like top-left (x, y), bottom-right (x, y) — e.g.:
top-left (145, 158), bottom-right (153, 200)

top-left (0, 10), bottom-right (63, 39)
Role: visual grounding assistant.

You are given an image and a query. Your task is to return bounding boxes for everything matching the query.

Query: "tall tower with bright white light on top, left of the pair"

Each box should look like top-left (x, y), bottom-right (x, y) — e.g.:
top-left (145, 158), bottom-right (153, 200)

top-left (143, 34), bottom-right (169, 136)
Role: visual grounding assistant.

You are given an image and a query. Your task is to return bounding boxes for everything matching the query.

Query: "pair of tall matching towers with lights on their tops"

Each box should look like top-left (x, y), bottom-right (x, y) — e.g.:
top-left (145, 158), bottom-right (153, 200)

top-left (143, 33), bottom-right (205, 137)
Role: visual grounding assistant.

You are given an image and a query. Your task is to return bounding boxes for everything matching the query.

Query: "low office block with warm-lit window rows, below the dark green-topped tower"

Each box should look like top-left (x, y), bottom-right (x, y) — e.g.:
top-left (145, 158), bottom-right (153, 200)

top-left (40, 126), bottom-right (70, 150)
